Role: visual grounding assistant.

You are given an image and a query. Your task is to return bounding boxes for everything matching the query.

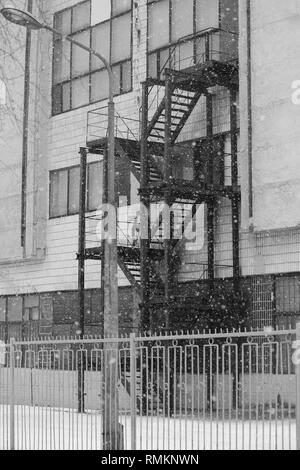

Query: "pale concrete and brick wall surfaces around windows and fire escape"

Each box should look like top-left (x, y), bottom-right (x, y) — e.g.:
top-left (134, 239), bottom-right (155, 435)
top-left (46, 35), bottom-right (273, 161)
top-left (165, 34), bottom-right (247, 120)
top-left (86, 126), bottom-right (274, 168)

top-left (0, 0), bottom-right (300, 330)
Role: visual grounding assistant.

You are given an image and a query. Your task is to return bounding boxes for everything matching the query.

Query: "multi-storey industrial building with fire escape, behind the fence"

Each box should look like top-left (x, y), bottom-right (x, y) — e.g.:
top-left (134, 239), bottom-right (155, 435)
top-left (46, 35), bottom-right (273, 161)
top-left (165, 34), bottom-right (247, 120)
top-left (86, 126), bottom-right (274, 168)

top-left (0, 0), bottom-right (300, 337)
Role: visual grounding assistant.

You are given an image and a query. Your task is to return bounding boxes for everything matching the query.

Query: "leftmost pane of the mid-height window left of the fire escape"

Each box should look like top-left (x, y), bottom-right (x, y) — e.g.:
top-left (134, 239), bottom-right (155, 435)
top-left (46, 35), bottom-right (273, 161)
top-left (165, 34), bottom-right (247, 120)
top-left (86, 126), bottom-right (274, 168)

top-left (50, 170), bottom-right (68, 217)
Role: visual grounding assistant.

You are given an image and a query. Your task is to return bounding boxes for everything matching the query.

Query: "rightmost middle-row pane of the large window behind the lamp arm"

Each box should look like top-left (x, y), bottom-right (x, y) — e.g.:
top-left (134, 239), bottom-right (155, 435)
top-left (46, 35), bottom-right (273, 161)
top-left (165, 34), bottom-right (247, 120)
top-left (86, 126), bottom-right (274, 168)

top-left (111, 13), bottom-right (131, 63)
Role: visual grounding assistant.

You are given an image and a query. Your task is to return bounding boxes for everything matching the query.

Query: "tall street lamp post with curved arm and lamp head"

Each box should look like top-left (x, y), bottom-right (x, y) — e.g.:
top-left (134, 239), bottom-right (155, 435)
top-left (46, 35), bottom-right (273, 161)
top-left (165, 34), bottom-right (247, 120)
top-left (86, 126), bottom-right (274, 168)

top-left (0, 7), bottom-right (122, 450)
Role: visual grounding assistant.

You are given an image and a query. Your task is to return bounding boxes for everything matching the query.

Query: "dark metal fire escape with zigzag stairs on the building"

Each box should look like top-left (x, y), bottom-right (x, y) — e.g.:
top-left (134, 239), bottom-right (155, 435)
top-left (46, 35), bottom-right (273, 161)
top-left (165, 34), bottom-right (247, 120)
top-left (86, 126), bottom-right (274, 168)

top-left (79, 29), bottom-right (240, 329)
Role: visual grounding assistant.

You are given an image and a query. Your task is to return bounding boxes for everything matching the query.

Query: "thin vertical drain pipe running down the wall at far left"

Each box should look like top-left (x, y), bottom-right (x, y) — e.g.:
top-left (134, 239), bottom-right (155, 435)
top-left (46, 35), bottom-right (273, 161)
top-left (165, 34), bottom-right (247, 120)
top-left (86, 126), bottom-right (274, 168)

top-left (21, 0), bottom-right (33, 252)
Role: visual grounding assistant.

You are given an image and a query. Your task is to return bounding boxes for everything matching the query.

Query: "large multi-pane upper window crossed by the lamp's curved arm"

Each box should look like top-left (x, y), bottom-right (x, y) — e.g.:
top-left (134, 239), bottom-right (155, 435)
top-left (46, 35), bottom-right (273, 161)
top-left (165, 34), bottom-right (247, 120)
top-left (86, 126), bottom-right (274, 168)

top-left (52, 0), bottom-right (132, 115)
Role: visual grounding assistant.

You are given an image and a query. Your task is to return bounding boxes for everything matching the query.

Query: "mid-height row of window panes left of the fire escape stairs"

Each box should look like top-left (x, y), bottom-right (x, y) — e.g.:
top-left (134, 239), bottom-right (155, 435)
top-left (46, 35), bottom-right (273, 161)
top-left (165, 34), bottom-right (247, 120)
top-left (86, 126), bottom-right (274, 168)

top-left (49, 161), bottom-right (103, 218)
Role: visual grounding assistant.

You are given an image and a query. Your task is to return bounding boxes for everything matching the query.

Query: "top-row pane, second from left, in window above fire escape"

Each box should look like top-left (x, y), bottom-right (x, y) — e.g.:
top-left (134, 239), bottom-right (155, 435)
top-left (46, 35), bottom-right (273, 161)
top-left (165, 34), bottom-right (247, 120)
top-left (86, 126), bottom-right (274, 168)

top-left (171, 0), bottom-right (194, 42)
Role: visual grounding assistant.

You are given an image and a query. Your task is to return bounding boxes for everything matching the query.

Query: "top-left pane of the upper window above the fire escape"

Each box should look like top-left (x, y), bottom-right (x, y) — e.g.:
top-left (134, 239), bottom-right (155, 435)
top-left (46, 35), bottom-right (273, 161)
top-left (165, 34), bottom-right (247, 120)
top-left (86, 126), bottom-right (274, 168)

top-left (148, 0), bottom-right (169, 51)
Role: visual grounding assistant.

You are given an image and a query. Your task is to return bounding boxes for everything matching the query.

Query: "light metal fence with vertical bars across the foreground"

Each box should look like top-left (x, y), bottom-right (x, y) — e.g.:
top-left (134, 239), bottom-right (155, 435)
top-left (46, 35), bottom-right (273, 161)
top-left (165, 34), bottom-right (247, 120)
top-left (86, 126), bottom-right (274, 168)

top-left (0, 325), bottom-right (300, 450)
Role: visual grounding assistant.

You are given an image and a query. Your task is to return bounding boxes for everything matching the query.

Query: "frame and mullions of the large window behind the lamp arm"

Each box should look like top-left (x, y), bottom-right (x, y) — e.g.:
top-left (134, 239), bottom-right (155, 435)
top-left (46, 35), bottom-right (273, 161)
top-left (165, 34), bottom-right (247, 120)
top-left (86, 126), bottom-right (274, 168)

top-left (51, 0), bottom-right (133, 117)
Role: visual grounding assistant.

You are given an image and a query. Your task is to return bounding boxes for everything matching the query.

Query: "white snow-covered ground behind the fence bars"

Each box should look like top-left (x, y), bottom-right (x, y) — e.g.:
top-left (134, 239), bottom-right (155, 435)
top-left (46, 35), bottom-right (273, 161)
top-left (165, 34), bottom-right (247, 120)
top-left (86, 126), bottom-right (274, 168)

top-left (0, 406), bottom-right (296, 450)
